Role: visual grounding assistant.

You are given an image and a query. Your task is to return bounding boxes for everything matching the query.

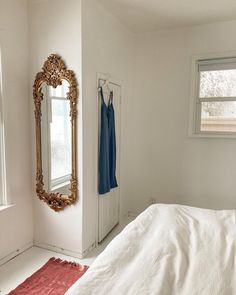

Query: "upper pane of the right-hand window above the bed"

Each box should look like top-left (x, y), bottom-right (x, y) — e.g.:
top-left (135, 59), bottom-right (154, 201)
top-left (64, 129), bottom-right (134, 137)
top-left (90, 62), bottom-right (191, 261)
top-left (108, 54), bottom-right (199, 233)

top-left (199, 69), bottom-right (236, 98)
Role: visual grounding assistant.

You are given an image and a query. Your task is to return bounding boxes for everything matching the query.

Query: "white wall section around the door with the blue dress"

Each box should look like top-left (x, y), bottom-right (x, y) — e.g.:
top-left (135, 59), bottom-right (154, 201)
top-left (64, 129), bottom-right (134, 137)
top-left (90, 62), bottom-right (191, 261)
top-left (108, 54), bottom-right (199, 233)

top-left (82, 0), bottom-right (134, 249)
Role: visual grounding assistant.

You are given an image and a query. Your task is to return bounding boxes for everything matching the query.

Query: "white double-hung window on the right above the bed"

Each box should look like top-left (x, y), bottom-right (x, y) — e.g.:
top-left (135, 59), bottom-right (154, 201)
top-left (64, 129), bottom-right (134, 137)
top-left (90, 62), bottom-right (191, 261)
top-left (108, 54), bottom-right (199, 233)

top-left (190, 57), bottom-right (236, 136)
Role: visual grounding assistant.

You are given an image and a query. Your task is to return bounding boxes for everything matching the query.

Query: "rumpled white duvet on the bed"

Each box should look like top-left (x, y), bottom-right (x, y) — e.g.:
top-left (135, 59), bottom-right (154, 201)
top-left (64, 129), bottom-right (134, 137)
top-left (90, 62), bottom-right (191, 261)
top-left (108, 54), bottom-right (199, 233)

top-left (66, 205), bottom-right (236, 295)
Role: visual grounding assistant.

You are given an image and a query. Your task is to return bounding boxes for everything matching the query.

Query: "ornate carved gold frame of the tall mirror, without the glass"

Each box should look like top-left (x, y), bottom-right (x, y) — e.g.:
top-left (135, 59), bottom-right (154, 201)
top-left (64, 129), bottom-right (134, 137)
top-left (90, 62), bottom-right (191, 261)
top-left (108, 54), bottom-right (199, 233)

top-left (33, 54), bottom-right (78, 211)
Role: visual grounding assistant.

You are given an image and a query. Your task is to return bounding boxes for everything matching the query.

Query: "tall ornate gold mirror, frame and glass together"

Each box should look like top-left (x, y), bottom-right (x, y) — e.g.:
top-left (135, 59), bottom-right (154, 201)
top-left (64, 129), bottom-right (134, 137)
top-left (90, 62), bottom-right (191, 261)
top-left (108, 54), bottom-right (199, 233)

top-left (33, 54), bottom-right (77, 211)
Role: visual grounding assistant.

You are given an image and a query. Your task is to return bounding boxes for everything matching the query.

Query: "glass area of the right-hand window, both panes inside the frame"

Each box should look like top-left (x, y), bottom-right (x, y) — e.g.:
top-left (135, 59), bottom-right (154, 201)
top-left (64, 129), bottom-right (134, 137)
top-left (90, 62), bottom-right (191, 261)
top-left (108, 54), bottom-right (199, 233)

top-left (199, 69), bottom-right (236, 132)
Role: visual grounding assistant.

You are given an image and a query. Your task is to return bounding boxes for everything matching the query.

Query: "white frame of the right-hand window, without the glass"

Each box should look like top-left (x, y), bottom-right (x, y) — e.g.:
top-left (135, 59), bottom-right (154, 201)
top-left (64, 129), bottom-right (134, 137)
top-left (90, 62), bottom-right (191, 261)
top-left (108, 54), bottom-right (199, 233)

top-left (188, 51), bottom-right (236, 138)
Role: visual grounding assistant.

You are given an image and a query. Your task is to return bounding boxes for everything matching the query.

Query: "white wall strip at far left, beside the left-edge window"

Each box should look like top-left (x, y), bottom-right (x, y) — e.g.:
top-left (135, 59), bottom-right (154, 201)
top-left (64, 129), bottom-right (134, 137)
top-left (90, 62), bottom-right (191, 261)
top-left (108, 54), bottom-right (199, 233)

top-left (0, 0), bottom-right (33, 259)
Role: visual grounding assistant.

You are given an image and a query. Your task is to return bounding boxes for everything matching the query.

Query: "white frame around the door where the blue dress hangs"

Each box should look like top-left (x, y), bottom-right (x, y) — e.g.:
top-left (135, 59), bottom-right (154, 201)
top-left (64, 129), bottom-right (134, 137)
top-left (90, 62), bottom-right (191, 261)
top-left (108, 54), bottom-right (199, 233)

top-left (95, 72), bottom-right (124, 246)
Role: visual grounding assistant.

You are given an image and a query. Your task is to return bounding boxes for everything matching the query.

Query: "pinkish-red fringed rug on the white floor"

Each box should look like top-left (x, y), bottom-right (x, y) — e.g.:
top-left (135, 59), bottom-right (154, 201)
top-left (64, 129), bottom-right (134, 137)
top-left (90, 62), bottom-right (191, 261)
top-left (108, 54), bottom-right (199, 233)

top-left (8, 258), bottom-right (88, 295)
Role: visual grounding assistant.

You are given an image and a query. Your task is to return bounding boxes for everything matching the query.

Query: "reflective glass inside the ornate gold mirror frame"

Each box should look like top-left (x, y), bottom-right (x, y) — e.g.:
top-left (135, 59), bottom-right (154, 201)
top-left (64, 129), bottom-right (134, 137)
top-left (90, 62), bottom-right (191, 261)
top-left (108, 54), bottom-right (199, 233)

top-left (41, 80), bottom-right (72, 195)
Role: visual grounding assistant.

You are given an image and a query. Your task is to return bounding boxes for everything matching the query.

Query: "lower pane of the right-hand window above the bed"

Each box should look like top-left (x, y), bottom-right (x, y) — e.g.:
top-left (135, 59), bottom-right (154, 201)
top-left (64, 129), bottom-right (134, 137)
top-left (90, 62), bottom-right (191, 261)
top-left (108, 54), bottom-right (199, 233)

top-left (201, 101), bottom-right (236, 132)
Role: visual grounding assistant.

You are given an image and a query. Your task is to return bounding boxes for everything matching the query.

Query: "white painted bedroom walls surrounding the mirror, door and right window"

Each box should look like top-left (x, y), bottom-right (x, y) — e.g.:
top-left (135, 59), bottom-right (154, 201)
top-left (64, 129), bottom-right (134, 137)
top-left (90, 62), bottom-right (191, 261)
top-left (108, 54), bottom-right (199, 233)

top-left (4, 0), bottom-right (236, 257)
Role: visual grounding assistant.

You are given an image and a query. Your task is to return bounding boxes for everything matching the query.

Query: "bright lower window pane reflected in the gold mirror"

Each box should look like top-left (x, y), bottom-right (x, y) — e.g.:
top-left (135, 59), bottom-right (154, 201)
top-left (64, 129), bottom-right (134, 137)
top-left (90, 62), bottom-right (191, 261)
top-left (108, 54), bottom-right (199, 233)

top-left (50, 99), bottom-right (71, 180)
